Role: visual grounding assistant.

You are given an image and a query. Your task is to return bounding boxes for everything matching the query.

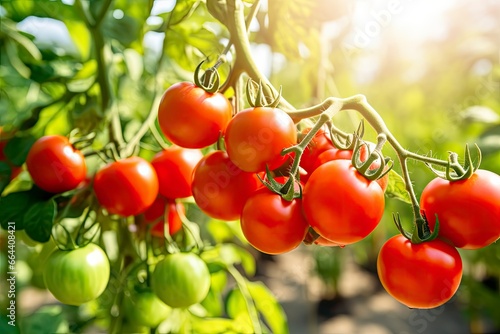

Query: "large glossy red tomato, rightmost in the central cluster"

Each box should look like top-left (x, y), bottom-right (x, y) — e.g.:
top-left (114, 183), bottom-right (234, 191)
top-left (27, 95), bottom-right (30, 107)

top-left (303, 160), bottom-right (385, 245)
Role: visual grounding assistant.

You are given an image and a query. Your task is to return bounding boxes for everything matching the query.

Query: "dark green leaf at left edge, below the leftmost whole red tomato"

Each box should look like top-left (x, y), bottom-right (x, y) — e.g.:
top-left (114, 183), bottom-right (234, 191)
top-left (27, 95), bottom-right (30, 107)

top-left (0, 188), bottom-right (48, 230)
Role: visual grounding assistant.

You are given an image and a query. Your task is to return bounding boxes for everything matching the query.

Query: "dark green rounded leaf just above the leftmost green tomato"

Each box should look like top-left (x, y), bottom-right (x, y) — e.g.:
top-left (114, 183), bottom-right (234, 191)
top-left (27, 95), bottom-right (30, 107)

top-left (24, 199), bottom-right (57, 242)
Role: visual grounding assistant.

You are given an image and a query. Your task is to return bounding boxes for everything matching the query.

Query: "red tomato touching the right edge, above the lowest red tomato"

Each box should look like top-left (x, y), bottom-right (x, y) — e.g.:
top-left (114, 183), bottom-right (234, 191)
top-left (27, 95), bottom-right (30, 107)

top-left (420, 169), bottom-right (500, 249)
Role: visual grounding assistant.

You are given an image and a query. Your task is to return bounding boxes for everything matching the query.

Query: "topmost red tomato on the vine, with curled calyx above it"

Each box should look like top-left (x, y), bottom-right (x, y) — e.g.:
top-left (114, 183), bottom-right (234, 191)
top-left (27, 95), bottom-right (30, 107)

top-left (158, 82), bottom-right (232, 148)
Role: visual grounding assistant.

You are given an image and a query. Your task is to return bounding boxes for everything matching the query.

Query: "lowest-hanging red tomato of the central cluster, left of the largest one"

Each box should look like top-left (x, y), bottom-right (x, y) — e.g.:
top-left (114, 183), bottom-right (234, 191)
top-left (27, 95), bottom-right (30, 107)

top-left (241, 188), bottom-right (309, 254)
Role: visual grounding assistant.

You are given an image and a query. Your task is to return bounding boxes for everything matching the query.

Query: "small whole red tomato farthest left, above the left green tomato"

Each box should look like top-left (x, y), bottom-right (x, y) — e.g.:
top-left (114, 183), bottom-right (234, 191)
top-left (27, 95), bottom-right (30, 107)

top-left (26, 135), bottom-right (87, 193)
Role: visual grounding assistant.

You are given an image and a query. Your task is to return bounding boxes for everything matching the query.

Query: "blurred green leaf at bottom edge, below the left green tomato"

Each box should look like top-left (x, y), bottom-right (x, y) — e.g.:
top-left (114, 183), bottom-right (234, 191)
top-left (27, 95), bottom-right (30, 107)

top-left (21, 305), bottom-right (70, 334)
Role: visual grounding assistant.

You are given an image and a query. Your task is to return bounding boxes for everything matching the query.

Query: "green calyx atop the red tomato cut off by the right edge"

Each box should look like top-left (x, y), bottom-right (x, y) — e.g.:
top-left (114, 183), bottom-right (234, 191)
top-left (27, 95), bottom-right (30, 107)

top-left (425, 144), bottom-right (482, 181)
